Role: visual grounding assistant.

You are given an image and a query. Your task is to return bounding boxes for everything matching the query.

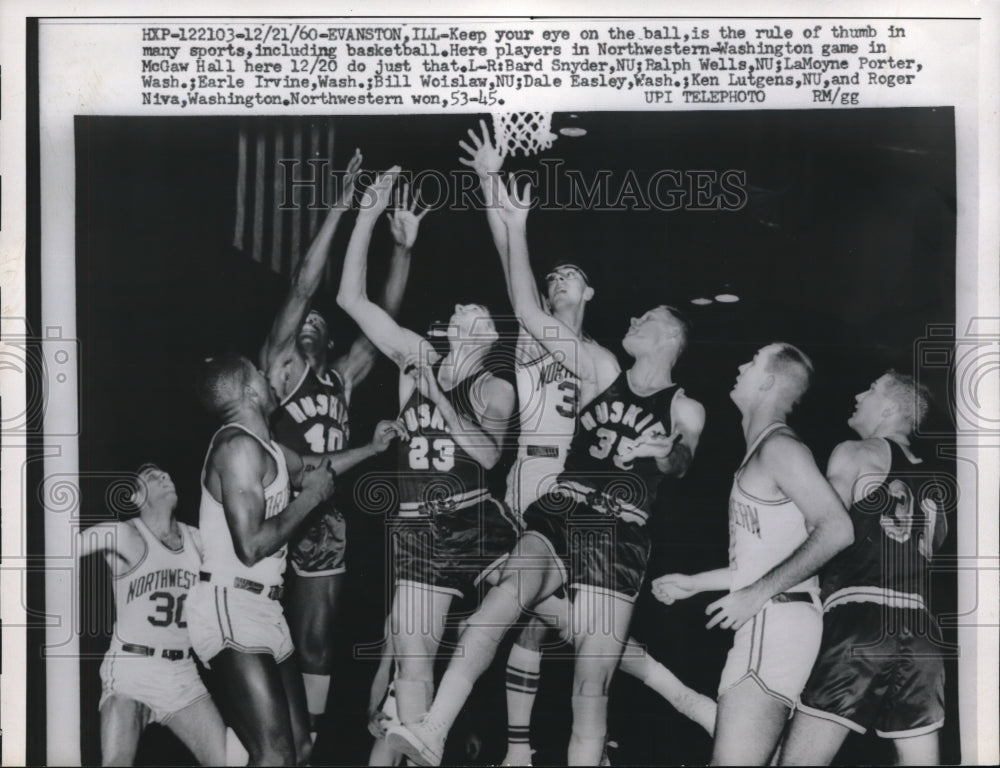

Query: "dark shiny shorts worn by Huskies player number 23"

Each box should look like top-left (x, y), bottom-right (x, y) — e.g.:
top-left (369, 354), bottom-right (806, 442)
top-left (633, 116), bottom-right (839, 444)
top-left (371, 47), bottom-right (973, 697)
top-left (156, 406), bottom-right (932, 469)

top-left (390, 498), bottom-right (520, 597)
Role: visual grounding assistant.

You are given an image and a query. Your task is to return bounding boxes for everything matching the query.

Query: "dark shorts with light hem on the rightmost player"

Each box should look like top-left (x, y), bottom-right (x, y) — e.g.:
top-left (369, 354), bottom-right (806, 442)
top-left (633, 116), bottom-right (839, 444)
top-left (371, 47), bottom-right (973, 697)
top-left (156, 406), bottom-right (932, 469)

top-left (800, 602), bottom-right (944, 738)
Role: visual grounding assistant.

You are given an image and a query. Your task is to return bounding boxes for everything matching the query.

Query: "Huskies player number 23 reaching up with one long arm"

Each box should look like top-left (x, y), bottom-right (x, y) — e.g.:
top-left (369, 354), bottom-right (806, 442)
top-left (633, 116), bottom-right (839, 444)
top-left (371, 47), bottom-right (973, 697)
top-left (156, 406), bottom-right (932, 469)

top-left (337, 166), bottom-right (517, 746)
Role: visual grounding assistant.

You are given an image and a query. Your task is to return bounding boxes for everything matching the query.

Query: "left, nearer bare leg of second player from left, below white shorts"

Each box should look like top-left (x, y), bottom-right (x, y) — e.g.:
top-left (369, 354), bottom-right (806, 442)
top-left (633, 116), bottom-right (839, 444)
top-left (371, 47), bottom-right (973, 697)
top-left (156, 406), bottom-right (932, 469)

top-left (212, 648), bottom-right (301, 765)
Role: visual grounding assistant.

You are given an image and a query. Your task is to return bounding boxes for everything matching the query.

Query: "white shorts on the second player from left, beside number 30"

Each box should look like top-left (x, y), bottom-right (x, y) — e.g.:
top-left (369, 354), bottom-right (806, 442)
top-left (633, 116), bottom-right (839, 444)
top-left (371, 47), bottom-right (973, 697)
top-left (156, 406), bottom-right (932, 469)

top-left (186, 581), bottom-right (295, 666)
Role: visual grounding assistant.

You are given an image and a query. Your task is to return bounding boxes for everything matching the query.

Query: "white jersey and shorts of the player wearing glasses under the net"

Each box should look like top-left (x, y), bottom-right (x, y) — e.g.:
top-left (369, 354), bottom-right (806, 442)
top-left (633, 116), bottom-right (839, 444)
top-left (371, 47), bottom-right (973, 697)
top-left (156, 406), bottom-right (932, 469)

top-left (506, 330), bottom-right (580, 515)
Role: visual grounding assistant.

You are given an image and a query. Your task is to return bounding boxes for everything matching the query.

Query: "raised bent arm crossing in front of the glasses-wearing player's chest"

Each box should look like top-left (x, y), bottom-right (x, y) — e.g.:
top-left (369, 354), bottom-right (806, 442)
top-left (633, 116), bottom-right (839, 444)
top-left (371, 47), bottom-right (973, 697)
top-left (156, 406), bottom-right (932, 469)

top-left (497, 179), bottom-right (596, 382)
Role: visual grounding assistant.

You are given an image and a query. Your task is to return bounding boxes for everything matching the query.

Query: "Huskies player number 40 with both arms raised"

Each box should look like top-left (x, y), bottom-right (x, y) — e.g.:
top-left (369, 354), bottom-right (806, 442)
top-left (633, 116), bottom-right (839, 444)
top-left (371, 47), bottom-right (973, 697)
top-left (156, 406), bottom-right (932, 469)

top-left (261, 150), bottom-right (426, 731)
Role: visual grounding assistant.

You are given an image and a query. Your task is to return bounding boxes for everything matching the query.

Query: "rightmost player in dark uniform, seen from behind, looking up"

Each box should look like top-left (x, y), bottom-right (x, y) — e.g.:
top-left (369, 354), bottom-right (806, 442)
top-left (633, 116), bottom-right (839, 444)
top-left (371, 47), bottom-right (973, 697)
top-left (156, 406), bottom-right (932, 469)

top-left (781, 371), bottom-right (947, 765)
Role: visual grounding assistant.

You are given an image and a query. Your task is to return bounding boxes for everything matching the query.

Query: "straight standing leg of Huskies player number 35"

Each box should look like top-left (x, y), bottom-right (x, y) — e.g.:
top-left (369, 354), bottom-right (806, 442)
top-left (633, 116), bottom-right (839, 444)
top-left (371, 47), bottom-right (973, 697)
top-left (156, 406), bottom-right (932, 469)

top-left (567, 589), bottom-right (632, 765)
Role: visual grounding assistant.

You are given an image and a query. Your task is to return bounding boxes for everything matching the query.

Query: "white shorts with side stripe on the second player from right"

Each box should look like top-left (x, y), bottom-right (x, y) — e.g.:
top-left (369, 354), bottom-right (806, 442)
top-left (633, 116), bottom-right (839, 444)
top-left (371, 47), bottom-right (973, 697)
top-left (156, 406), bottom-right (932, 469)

top-left (719, 598), bottom-right (823, 709)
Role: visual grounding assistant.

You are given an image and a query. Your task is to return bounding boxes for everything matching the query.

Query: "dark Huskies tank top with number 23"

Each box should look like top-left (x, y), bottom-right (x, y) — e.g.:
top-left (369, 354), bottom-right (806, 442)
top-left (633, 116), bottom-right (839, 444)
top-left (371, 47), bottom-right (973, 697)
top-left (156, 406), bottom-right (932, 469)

top-left (396, 358), bottom-right (487, 514)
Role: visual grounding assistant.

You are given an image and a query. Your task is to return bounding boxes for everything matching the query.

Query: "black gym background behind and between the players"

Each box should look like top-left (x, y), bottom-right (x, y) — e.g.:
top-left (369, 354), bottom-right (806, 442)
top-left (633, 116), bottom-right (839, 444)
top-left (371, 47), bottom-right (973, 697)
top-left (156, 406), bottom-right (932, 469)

top-left (76, 108), bottom-right (959, 764)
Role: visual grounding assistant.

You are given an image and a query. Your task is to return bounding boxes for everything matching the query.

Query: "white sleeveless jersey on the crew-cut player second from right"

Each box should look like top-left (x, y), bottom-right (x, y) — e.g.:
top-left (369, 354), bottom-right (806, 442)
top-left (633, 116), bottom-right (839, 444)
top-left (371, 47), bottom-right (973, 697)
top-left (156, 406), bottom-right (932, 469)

top-left (729, 422), bottom-right (819, 592)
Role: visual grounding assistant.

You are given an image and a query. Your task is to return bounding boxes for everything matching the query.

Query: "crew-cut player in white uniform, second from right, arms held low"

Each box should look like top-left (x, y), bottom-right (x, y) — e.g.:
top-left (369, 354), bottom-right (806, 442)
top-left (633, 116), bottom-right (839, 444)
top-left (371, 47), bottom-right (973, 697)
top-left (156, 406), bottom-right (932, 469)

top-left (653, 343), bottom-right (852, 765)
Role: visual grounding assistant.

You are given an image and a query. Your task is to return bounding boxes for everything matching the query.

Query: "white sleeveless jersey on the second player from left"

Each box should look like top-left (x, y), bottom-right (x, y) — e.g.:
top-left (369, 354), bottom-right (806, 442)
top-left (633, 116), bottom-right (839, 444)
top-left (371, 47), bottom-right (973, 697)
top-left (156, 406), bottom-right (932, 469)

top-left (199, 424), bottom-right (291, 587)
